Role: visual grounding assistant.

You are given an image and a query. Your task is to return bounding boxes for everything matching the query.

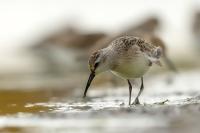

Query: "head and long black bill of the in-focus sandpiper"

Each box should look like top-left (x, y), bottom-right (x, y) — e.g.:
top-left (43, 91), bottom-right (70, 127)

top-left (83, 50), bottom-right (109, 97)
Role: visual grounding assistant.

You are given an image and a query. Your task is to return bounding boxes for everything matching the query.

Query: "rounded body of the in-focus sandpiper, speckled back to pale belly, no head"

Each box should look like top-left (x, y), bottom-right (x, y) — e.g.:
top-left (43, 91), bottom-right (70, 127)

top-left (103, 36), bottom-right (161, 79)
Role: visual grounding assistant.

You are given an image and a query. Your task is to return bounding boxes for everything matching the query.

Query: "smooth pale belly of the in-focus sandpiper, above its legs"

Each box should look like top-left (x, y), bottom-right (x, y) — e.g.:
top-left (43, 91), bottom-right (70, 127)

top-left (111, 56), bottom-right (150, 79)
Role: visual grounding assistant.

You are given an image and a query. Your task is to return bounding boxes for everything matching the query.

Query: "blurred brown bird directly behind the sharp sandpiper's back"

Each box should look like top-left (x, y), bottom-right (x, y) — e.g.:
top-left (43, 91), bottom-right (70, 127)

top-left (91, 17), bottom-right (177, 72)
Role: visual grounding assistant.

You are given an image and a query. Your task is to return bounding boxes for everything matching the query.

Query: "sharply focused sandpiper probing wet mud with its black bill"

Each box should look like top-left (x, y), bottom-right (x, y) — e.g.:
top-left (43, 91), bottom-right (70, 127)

top-left (83, 36), bottom-right (162, 105)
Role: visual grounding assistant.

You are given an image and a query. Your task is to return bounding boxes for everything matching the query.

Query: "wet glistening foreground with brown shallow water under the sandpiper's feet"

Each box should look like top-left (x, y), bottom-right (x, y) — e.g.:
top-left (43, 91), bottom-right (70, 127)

top-left (0, 71), bottom-right (200, 133)
